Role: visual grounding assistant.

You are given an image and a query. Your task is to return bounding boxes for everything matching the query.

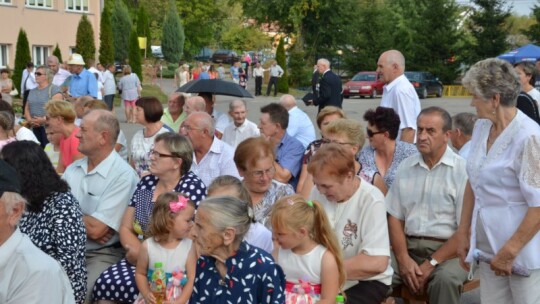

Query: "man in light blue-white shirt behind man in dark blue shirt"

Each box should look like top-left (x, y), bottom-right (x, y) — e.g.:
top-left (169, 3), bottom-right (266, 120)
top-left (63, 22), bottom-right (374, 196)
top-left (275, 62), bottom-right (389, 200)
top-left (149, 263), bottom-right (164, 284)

top-left (279, 94), bottom-right (316, 149)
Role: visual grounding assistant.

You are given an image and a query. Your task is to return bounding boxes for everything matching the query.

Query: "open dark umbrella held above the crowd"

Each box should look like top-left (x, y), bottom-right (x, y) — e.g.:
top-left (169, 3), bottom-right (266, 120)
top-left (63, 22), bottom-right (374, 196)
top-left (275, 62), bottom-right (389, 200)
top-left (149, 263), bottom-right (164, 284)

top-left (176, 79), bottom-right (253, 98)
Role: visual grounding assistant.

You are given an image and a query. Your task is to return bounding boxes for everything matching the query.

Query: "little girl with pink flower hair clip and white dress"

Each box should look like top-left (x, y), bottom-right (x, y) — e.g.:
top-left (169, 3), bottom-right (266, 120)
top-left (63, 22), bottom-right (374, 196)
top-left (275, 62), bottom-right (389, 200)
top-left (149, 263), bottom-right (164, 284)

top-left (135, 192), bottom-right (197, 304)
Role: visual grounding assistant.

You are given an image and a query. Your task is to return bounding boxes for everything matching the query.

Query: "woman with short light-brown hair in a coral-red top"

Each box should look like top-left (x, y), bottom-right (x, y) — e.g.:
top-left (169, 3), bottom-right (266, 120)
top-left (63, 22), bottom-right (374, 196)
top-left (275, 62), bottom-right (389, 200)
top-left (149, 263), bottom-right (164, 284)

top-left (45, 99), bottom-right (83, 173)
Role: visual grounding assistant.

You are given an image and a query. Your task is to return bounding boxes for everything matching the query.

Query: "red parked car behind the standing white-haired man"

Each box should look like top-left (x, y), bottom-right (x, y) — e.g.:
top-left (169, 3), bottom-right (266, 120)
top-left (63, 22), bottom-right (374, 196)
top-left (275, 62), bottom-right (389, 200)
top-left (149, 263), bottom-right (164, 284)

top-left (343, 72), bottom-right (384, 98)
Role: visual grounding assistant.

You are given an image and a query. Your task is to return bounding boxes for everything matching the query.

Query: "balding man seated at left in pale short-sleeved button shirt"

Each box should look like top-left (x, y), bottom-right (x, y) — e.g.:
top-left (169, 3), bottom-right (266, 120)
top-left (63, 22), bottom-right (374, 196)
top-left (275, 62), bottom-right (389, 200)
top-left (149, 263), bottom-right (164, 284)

top-left (63, 110), bottom-right (139, 302)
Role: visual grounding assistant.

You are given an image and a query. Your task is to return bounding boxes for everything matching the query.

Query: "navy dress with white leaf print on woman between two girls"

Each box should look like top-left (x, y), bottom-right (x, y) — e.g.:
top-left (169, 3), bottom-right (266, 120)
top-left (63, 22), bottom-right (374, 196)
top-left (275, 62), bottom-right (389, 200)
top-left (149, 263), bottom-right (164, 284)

top-left (189, 242), bottom-right (285, 304)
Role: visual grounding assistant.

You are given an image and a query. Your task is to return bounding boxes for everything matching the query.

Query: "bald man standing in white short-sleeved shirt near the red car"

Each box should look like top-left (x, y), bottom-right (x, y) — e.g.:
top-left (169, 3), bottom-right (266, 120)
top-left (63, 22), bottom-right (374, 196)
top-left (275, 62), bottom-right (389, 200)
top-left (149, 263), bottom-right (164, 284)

top-left (377, 50), bottom-right (420, 143)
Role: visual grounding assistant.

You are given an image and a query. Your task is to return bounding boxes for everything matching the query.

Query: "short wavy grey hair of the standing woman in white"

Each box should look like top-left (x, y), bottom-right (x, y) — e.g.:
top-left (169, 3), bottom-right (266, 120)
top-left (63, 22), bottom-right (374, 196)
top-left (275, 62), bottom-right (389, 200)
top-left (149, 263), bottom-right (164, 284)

top-left (462, 58), bottom-right (521, 107)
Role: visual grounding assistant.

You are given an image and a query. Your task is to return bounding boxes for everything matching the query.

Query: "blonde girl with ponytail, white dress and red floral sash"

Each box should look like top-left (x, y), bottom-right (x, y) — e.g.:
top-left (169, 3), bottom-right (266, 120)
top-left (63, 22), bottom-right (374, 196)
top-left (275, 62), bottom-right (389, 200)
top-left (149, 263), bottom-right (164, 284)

top-left (270, 195), bottom-right (345, 304)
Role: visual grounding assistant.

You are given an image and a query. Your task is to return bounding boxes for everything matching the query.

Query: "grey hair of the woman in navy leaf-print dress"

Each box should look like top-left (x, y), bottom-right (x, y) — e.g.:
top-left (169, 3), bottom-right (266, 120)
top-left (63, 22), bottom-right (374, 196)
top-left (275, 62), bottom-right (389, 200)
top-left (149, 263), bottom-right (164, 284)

top-left (198, 196), bottom-right (253, 242)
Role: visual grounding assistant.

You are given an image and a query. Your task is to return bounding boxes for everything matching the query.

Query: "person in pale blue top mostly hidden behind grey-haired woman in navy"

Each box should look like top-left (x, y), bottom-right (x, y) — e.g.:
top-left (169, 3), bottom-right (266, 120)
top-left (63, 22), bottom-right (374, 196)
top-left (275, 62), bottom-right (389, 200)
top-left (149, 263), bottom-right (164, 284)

top-left (208, 175), bottom-right (273, 254)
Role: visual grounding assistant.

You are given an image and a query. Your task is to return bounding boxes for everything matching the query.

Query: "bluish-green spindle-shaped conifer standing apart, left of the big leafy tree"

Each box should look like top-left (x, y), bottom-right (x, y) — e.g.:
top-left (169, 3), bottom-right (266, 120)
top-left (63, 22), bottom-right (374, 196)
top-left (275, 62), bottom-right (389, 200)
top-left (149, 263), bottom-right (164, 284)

top-left (161, 0), bottom-right (185, 62)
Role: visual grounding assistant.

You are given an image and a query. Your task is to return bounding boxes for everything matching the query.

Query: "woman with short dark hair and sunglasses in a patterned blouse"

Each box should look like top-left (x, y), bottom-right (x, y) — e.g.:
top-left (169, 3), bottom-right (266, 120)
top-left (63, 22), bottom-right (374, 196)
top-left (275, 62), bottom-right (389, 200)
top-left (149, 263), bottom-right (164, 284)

top-left (360, 107), bottom-right (418, 194)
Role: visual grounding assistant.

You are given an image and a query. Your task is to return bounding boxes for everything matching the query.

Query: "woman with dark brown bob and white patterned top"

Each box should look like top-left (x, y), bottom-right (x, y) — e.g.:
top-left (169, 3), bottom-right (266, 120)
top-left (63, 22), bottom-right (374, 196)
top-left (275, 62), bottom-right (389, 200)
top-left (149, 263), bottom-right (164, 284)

top-left (129, 97), bottom-right (172, 176)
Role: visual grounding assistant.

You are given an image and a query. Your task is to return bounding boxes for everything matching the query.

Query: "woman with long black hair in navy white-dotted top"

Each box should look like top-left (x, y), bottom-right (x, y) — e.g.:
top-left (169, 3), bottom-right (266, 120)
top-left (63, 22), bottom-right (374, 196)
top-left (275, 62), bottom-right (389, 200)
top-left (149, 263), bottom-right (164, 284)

top-left (2, 141), bottom-right (86, 303)
